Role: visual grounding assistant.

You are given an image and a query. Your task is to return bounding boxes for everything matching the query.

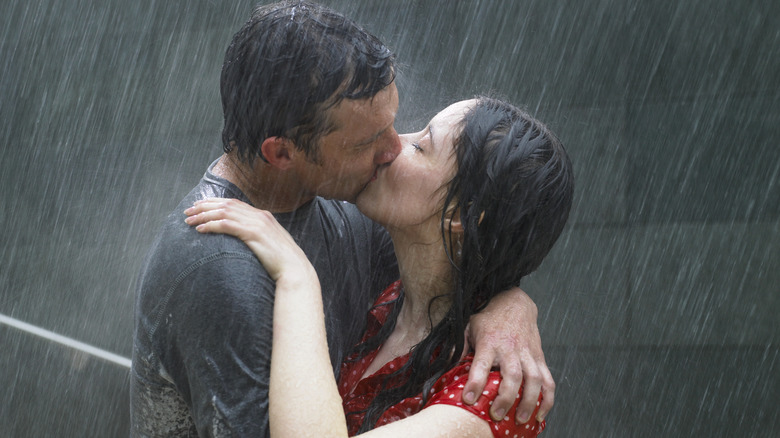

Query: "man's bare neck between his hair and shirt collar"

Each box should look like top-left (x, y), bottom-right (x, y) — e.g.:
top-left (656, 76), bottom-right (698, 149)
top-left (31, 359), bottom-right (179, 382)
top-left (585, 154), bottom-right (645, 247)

top-left (211, 154), bottom-right (314, 213)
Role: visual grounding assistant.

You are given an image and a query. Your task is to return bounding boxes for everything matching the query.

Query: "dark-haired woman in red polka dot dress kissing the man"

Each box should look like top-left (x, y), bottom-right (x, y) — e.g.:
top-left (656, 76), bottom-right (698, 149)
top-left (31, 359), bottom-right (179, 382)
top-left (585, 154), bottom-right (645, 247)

top-left (186, 98), bottom-right (573, 438)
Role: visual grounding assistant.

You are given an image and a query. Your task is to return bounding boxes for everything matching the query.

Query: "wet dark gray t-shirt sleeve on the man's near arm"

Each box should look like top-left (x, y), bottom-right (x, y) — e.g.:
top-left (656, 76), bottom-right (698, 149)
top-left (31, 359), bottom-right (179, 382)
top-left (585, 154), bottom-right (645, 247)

top-left (161, 253), bottom-right (275, 437)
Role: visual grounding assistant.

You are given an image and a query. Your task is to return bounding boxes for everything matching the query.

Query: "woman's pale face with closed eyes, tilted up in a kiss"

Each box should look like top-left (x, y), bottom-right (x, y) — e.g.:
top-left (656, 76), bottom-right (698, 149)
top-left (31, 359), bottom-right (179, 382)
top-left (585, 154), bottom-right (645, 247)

top-left (356, 100), bottom-right (476, 233)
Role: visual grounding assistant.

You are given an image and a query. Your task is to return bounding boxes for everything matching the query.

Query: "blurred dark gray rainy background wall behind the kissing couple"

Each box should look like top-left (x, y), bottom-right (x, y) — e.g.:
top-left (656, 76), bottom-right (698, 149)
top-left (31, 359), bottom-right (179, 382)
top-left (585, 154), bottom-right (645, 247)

top-left (0, 0), bottom-right (780, 438)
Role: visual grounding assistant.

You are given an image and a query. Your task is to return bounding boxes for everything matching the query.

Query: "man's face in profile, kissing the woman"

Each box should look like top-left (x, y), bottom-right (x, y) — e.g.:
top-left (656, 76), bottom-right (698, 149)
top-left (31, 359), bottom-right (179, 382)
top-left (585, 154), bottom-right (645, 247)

top-left (294, 83), bottom-right (401, 202)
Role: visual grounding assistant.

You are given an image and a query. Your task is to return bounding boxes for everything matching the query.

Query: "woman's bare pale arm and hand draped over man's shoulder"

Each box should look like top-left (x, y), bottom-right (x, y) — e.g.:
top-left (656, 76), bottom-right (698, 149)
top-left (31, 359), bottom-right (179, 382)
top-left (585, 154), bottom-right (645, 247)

top-left (184, 198), bottom-right (347, 437)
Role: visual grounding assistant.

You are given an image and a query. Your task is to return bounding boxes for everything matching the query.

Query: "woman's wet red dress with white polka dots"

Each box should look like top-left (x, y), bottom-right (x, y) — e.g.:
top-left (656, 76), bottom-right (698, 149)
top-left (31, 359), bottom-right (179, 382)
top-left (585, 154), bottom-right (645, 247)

top-left (339, 281), bottom-right (545, 438)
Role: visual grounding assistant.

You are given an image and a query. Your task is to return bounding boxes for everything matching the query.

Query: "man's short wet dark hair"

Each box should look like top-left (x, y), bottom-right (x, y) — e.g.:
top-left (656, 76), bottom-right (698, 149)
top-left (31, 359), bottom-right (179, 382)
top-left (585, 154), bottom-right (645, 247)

top-left (220, 1), bottom-right (395, 163)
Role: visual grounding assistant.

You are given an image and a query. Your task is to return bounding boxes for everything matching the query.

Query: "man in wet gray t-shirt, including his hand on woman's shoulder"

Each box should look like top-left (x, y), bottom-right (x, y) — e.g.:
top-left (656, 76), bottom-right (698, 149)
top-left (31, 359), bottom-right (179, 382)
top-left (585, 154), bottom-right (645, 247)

top-left (131, 2), bottom-right (554, 437)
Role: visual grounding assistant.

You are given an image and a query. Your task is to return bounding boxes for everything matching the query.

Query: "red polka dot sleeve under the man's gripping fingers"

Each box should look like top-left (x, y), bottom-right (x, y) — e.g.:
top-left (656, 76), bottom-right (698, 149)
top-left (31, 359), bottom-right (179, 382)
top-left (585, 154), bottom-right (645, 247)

top-left (425, 363), bottom-right (546, 438)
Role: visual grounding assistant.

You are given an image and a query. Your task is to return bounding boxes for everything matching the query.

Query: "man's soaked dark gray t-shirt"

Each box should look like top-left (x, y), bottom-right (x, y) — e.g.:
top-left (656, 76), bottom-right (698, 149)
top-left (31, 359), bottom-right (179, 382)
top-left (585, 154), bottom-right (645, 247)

top-left (131, 159), bottom-right (398, 437)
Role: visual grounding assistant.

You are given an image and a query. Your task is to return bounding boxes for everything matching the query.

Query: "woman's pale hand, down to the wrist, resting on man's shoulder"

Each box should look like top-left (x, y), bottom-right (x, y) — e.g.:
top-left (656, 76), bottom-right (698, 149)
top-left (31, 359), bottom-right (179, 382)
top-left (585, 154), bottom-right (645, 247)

top-left (184, 198), bottom-right (319, 287)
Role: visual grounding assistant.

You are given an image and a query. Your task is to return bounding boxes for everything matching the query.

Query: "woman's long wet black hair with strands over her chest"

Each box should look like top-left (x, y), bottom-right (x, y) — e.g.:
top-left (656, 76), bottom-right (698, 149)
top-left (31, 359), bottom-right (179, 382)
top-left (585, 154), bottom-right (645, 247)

top-left (357, 97), bottom-right (574, 432)
